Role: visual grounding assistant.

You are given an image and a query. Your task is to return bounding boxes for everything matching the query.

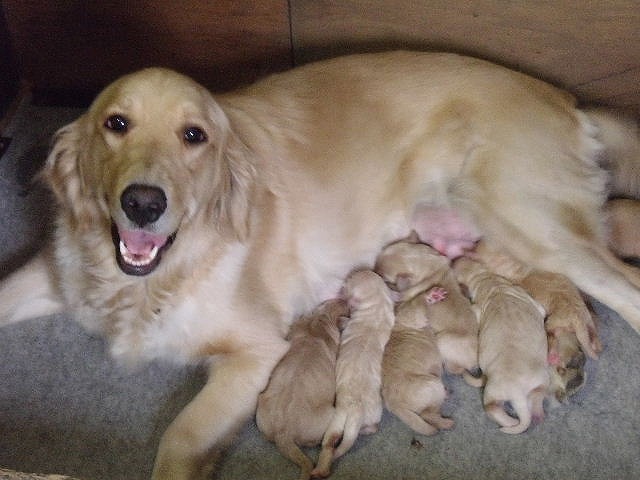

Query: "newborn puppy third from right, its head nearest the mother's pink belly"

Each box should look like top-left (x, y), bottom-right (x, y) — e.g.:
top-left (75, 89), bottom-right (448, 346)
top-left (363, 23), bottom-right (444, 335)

top-left (376, 236), bottom-right (478, 381)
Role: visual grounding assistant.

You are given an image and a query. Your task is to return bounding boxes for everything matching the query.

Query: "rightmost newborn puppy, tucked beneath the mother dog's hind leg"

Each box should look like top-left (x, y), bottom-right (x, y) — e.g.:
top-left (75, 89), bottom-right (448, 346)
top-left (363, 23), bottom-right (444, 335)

top-left (474, 242), bottom-right (602, 402)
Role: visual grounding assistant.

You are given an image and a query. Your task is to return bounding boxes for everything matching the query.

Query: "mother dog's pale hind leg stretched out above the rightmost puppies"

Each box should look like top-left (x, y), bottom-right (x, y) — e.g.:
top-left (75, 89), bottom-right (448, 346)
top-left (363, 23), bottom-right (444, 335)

top-left (451, 152), bottom-right (640, 333)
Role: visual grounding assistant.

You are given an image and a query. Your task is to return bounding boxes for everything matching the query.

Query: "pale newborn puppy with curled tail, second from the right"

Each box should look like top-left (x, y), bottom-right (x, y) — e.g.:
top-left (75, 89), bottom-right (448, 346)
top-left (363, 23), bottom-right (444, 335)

top-left (454, 258), bottom-right (549, 433)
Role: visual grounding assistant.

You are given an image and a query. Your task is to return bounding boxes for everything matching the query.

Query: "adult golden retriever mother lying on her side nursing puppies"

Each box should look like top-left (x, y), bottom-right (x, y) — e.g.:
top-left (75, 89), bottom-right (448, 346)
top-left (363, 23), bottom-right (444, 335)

top-left (0, 52), bottom-right (640, 480)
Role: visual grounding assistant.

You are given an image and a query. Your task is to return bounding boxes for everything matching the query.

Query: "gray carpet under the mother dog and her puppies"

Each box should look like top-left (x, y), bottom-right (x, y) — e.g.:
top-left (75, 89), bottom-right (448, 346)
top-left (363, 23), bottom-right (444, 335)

top-left (0, 98), bottom-right (640, 480)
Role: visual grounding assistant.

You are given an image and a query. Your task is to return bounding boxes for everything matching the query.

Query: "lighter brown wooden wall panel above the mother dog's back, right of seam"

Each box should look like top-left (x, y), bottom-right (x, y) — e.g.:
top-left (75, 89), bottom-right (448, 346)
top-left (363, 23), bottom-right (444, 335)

top-left (291, 0), bottom-right (640, 111)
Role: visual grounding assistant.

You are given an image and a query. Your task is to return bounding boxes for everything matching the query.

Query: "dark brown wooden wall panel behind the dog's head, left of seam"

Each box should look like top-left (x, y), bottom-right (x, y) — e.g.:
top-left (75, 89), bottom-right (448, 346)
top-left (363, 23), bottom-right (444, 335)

top-left (3, 0), bottom-right (292, 104)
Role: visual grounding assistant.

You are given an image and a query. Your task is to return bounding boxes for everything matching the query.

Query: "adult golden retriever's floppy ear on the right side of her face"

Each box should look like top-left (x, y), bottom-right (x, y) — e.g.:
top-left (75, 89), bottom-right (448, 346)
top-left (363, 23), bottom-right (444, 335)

top-left (210, 102), bottom-right (255, 241)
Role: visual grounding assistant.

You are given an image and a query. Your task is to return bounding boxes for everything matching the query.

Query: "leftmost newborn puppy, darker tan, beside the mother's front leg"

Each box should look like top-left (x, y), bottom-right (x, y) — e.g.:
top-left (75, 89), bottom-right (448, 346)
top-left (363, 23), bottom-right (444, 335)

top-left (256, 300), bottom-right (348, 480)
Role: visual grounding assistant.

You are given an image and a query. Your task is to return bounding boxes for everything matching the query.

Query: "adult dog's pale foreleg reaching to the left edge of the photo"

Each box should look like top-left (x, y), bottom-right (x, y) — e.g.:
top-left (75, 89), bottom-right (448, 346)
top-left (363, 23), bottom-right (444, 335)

top-left (0, 253), bottom-right (64, 326)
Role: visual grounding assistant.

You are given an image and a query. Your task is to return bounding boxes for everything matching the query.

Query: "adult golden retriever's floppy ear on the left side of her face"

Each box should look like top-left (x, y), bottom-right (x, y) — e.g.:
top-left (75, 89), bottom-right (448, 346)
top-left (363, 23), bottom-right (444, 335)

top-left (39, 117), bottom-right (88, 217)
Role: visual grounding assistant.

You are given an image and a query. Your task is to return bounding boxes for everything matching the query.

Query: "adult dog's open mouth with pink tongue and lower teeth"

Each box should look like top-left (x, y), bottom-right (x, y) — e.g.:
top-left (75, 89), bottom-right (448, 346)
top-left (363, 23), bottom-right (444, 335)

top-left (111, 223), bottom-right (176, 276)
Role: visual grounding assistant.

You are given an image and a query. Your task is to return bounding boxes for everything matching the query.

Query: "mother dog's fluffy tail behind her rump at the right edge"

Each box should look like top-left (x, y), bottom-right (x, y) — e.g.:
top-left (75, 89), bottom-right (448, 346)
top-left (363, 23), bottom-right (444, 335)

top-left (585, 108), bottom-right (640, 199)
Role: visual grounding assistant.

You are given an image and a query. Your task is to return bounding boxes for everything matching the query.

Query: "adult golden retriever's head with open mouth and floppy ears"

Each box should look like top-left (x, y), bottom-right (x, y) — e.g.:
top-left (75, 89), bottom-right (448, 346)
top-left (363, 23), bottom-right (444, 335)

top-left (44, 68), bottom-right (254, 275)
